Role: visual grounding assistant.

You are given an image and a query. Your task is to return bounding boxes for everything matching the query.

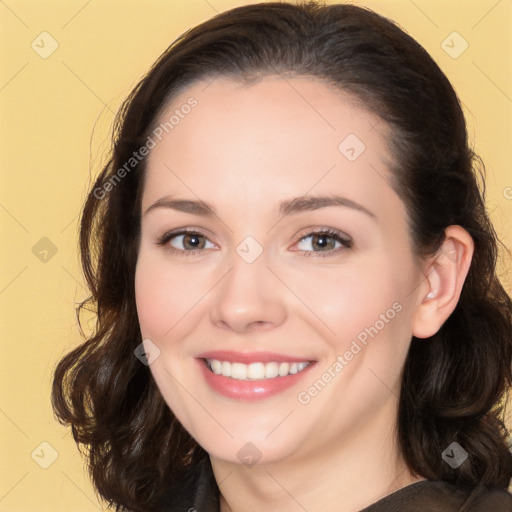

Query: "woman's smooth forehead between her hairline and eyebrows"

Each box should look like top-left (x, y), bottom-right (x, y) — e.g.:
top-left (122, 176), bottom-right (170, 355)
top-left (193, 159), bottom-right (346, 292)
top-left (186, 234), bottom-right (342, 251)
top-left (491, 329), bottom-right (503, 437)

top-left (143, 76), bottom-right (400, 218)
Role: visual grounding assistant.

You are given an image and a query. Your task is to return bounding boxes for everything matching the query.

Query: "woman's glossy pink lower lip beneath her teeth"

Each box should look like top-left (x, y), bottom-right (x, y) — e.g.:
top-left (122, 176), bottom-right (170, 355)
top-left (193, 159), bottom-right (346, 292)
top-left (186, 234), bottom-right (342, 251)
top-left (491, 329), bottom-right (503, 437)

top-left (197, 359), bottom-right (315, 401)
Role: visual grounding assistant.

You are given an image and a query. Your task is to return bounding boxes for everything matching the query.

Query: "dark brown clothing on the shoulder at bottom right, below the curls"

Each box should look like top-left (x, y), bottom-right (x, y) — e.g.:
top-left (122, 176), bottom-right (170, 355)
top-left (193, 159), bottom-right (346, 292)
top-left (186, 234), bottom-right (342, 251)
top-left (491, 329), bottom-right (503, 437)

top-left (361, 480), bottom-right (512, 512)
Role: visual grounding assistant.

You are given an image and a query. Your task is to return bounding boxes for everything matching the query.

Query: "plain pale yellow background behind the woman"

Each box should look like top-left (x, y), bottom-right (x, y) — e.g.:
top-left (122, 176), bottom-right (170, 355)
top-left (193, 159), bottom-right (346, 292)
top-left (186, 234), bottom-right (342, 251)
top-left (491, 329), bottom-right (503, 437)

top-left (0, 0), bottom-right (512, 512)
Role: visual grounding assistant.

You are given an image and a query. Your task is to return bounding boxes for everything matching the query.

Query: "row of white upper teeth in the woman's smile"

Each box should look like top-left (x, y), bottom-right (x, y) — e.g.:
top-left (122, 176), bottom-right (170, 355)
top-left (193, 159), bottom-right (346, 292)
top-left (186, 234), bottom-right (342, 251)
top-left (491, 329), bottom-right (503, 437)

top-left (206, 359), bottom-right (309, 380)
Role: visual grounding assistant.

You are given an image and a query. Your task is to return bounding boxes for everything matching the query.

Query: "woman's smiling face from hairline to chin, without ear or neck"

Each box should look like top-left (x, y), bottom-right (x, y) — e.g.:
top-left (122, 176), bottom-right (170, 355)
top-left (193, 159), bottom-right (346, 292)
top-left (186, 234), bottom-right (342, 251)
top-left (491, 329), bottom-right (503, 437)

top-left (135, 76), bottom-right (423, 465)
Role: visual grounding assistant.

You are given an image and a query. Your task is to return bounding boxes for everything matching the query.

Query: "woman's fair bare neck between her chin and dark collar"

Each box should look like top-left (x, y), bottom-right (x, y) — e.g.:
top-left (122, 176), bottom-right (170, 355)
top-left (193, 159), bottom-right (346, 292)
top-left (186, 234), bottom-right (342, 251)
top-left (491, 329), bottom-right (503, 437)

top-left (211, 406), bottom-right (424, 512)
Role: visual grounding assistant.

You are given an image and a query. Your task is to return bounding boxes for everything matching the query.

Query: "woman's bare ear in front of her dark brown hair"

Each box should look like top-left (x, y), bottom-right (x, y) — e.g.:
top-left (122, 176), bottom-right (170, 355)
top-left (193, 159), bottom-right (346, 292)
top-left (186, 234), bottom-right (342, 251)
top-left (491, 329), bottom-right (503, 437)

top-left (412, 226), bottom-right (474, 338)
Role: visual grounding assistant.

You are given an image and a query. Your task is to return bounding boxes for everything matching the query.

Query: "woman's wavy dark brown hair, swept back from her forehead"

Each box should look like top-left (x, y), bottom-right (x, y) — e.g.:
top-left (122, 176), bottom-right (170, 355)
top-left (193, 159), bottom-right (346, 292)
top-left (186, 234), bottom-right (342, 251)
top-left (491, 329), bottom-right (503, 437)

top-left (52, 2), bottom-right (512, 511)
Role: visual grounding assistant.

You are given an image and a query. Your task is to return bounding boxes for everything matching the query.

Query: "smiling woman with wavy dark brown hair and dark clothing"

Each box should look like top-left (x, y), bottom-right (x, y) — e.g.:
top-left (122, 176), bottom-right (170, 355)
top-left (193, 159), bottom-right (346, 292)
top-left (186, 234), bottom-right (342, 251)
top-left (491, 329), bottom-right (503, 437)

top-left (52, 2), bottom-right (512, 512)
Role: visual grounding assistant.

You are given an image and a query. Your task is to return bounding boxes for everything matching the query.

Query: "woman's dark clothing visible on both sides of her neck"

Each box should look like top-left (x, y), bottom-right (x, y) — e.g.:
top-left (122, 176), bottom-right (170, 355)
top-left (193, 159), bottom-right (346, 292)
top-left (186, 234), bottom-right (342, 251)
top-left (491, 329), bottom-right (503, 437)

top-left (161, 459), bottom-right (512, 512)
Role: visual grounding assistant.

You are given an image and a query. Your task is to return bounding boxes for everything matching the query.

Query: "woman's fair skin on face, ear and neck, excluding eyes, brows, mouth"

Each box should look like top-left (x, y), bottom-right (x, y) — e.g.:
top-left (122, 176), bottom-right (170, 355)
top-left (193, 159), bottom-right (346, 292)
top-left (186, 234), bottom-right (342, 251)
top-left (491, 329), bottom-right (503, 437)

top-left (135, 76), bottom-right (473, 512)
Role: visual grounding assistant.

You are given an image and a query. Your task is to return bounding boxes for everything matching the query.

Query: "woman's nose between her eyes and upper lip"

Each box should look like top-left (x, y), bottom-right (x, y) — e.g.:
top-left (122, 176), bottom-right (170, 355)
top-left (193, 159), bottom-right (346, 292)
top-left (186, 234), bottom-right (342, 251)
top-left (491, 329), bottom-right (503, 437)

top-left (210, 247), bottom-right (287, 333)
